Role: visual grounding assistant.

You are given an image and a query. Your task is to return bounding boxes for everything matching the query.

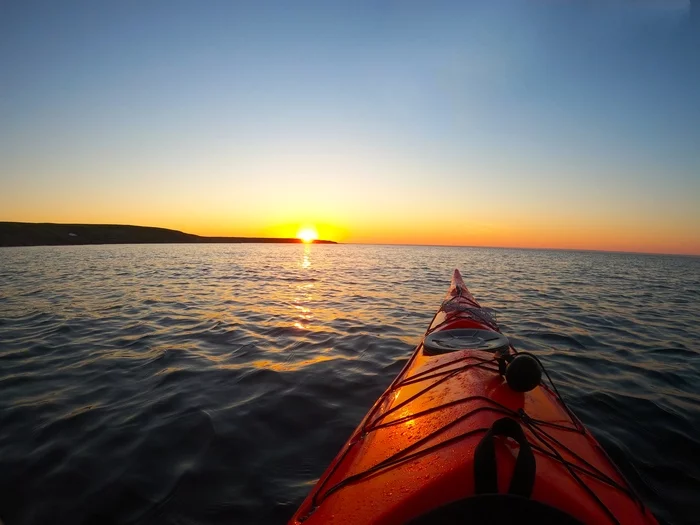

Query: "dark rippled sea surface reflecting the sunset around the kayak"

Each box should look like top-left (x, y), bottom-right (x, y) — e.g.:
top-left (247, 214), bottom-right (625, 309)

top-left (0, 244), bottom-right (700, 525)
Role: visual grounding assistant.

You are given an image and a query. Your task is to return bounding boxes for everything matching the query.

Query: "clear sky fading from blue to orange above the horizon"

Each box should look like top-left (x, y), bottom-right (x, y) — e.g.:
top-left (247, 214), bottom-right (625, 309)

top-left (0, 0), bottom-right (700, 254)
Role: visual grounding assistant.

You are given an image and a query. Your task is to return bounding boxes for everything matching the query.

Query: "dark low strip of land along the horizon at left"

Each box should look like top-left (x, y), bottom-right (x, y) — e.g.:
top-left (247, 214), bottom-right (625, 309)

top-left (0, 222), bottom-right (336, 246)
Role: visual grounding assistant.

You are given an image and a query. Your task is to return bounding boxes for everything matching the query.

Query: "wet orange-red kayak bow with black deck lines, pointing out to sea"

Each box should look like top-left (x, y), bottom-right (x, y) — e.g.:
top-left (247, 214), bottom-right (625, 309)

top-left (290, 270), bottom-right (657, 525)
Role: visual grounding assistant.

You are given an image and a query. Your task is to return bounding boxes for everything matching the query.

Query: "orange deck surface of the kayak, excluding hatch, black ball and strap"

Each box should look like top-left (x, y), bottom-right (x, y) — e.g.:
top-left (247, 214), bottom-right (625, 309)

top-left (291, 270), bottom-right (656, 524)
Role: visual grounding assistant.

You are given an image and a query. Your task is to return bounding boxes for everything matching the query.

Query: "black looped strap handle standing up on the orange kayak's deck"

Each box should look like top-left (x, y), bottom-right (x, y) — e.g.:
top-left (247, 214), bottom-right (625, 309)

top-left (474, 417), bottom-right (537, 498)
